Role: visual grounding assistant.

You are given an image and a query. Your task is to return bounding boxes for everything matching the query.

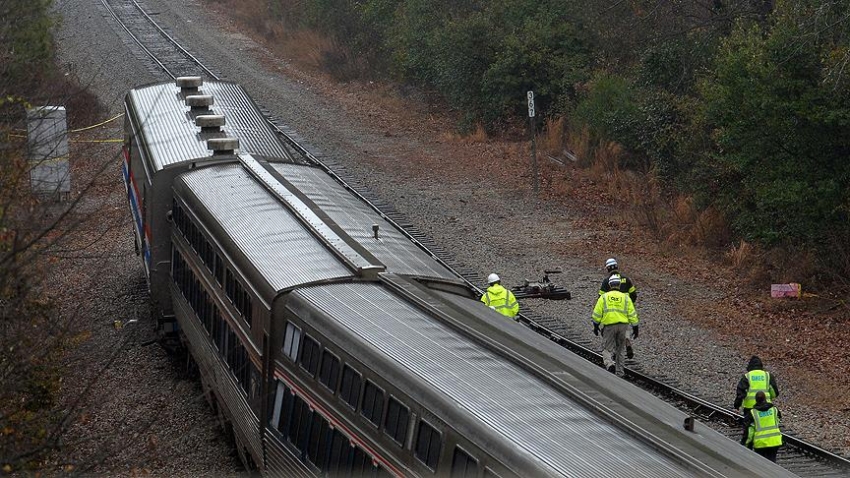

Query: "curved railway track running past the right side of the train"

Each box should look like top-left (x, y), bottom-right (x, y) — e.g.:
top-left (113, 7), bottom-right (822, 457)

top-left (101, 0), bottom-right (850, 477)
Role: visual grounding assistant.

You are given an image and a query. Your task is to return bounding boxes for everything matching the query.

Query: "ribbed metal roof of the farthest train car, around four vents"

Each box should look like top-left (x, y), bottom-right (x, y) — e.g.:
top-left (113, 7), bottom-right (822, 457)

top-left (125, 81), bottom-right (293, 171)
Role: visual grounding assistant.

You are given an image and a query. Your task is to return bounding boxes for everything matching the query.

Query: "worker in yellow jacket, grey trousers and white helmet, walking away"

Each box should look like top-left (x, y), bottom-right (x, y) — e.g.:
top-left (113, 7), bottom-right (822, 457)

top-left (591, 274), bottom-right (638, 376)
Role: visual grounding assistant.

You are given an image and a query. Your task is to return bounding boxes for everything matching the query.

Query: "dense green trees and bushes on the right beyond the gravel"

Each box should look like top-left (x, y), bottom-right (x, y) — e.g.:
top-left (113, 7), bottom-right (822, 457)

top-left (271, 0), bottom-right (850, 279)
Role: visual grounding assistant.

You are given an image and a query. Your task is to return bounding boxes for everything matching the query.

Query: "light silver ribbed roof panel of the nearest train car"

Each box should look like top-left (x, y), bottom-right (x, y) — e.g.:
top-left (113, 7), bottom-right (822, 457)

top-left (290, 283), bottom-right (783, 477)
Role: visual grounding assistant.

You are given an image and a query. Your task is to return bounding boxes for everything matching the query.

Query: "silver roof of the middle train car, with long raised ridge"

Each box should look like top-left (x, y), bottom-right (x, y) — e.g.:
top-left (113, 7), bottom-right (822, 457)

top-left (174, 155), bottom-right (457, 300)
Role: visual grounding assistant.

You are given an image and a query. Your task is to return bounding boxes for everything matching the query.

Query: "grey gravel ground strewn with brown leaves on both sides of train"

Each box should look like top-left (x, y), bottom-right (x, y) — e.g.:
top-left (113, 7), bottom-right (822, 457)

top-left (49, 0), bottom-right (850, 475)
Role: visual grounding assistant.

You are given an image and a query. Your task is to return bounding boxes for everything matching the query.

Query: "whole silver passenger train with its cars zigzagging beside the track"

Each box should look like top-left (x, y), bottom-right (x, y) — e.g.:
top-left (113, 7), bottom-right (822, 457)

top-left (124, 78), bottom-right (790, 478)
